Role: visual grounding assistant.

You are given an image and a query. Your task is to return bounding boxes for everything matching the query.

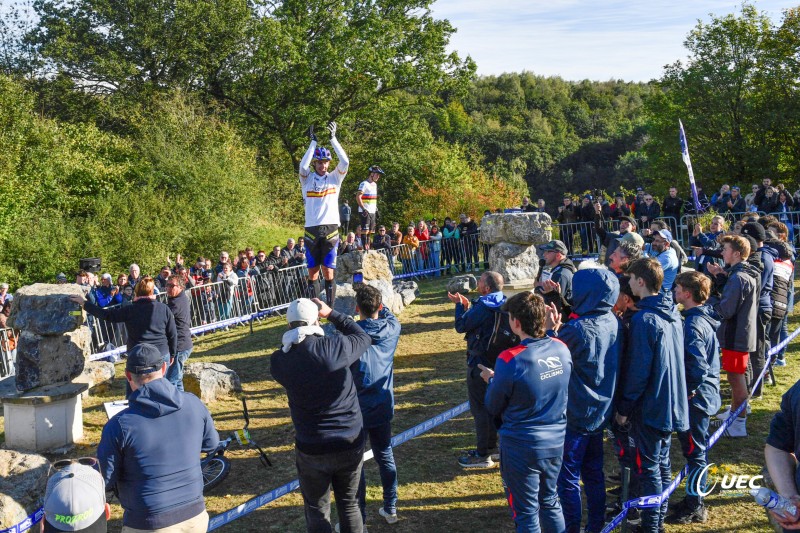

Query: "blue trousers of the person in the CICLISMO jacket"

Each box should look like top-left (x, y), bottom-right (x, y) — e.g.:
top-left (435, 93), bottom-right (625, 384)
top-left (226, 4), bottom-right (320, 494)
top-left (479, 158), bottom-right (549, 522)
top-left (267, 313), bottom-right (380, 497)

top-left (500, 439), bottom-right (564, 533)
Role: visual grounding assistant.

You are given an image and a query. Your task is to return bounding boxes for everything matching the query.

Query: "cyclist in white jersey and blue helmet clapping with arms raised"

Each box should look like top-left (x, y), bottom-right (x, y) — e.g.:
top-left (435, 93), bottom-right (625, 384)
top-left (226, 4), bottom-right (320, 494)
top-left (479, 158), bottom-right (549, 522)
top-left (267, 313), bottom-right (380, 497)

top-left (299, 122), bottom-right (350, 307)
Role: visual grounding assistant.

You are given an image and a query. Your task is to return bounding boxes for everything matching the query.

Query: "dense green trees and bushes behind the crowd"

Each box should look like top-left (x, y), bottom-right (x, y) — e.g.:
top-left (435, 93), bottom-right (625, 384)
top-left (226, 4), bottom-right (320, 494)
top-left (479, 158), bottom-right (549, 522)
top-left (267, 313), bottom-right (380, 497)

top-left (0, 0), bottom-right (800, 283)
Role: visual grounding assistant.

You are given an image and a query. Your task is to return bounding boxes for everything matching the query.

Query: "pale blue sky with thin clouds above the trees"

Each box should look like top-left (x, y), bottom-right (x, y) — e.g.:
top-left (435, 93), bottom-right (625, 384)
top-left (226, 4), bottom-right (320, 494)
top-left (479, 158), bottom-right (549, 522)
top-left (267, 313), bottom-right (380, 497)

top-left (432, 0), bottom-right (797, 81)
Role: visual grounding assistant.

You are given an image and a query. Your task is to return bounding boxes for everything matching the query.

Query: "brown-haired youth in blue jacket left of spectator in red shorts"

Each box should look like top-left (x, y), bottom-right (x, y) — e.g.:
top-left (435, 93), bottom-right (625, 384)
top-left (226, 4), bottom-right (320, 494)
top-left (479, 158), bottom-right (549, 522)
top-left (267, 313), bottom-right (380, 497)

top-left (670, 272), bottom-right (722, 524)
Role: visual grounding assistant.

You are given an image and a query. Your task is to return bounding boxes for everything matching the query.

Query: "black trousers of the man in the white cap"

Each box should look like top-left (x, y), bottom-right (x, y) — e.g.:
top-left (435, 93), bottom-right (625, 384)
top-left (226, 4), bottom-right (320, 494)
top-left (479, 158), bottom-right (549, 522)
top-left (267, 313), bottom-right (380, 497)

top-left (295, 447), bottom-right (364, 533)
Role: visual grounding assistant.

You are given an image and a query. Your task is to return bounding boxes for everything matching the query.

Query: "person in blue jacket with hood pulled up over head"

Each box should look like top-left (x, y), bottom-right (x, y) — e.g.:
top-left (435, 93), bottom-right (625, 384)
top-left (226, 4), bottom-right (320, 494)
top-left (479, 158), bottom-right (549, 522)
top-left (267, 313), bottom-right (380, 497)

top-left (548, 268), bottom-right (622, 533)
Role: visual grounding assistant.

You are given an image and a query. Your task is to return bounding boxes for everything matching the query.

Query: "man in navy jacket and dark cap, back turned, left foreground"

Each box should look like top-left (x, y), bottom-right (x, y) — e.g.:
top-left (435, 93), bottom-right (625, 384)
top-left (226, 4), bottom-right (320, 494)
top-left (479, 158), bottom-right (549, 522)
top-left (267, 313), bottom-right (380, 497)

top-left (97, 343), bottom-right (219, 533)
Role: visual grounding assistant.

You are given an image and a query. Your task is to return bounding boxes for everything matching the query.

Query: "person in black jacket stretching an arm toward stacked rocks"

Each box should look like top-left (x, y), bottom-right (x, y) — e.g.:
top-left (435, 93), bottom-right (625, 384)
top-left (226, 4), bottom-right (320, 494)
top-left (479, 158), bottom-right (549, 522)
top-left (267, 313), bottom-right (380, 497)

top-left (69, 276), bottom-right (178, 396)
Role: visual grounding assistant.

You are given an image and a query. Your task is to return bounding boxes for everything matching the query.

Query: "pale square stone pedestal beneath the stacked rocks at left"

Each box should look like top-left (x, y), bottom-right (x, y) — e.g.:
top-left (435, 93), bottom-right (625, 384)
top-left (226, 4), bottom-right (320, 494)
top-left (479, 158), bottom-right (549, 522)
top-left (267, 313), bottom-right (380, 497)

top-left (0, 383), bottom-right (89, 451)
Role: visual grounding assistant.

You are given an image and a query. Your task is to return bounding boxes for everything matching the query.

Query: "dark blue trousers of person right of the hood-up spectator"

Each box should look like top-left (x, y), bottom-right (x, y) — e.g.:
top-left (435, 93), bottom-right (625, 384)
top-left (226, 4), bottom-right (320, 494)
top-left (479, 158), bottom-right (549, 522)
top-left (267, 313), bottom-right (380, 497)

top-left (631, 420), bottom-right (672, 533)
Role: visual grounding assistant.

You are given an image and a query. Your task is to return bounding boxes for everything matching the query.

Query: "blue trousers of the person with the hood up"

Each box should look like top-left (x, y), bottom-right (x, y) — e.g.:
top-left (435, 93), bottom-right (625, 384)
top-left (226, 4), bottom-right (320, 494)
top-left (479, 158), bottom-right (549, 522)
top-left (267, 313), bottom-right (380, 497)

top-left (558, 428), bottom-right (606, 532)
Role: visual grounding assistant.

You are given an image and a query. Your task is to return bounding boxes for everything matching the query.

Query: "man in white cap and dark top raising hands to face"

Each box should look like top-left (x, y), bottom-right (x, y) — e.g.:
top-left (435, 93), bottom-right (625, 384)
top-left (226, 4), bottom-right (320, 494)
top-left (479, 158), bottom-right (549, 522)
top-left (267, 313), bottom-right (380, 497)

top-left (270, 298), bottom-right (372, 533)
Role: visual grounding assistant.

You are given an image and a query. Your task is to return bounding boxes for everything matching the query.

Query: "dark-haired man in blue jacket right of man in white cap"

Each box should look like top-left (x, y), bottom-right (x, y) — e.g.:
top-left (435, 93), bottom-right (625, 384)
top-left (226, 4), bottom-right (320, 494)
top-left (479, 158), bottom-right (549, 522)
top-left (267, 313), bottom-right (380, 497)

top-left (350, 285), bottom-right (400, 524)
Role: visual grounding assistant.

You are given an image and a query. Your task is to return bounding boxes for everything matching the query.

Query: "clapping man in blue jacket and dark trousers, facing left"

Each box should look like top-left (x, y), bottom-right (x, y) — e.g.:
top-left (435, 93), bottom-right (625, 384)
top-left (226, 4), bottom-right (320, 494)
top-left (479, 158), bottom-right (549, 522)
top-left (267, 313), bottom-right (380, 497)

top-left (447, 270), bottom-right (506, 468)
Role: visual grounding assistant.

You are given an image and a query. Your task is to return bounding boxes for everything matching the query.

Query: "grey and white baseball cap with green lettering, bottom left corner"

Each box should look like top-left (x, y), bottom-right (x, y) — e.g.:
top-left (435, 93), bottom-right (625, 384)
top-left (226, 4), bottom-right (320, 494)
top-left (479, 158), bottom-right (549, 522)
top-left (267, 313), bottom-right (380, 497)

top-left (44, 463), bottom-right (107, 533)
